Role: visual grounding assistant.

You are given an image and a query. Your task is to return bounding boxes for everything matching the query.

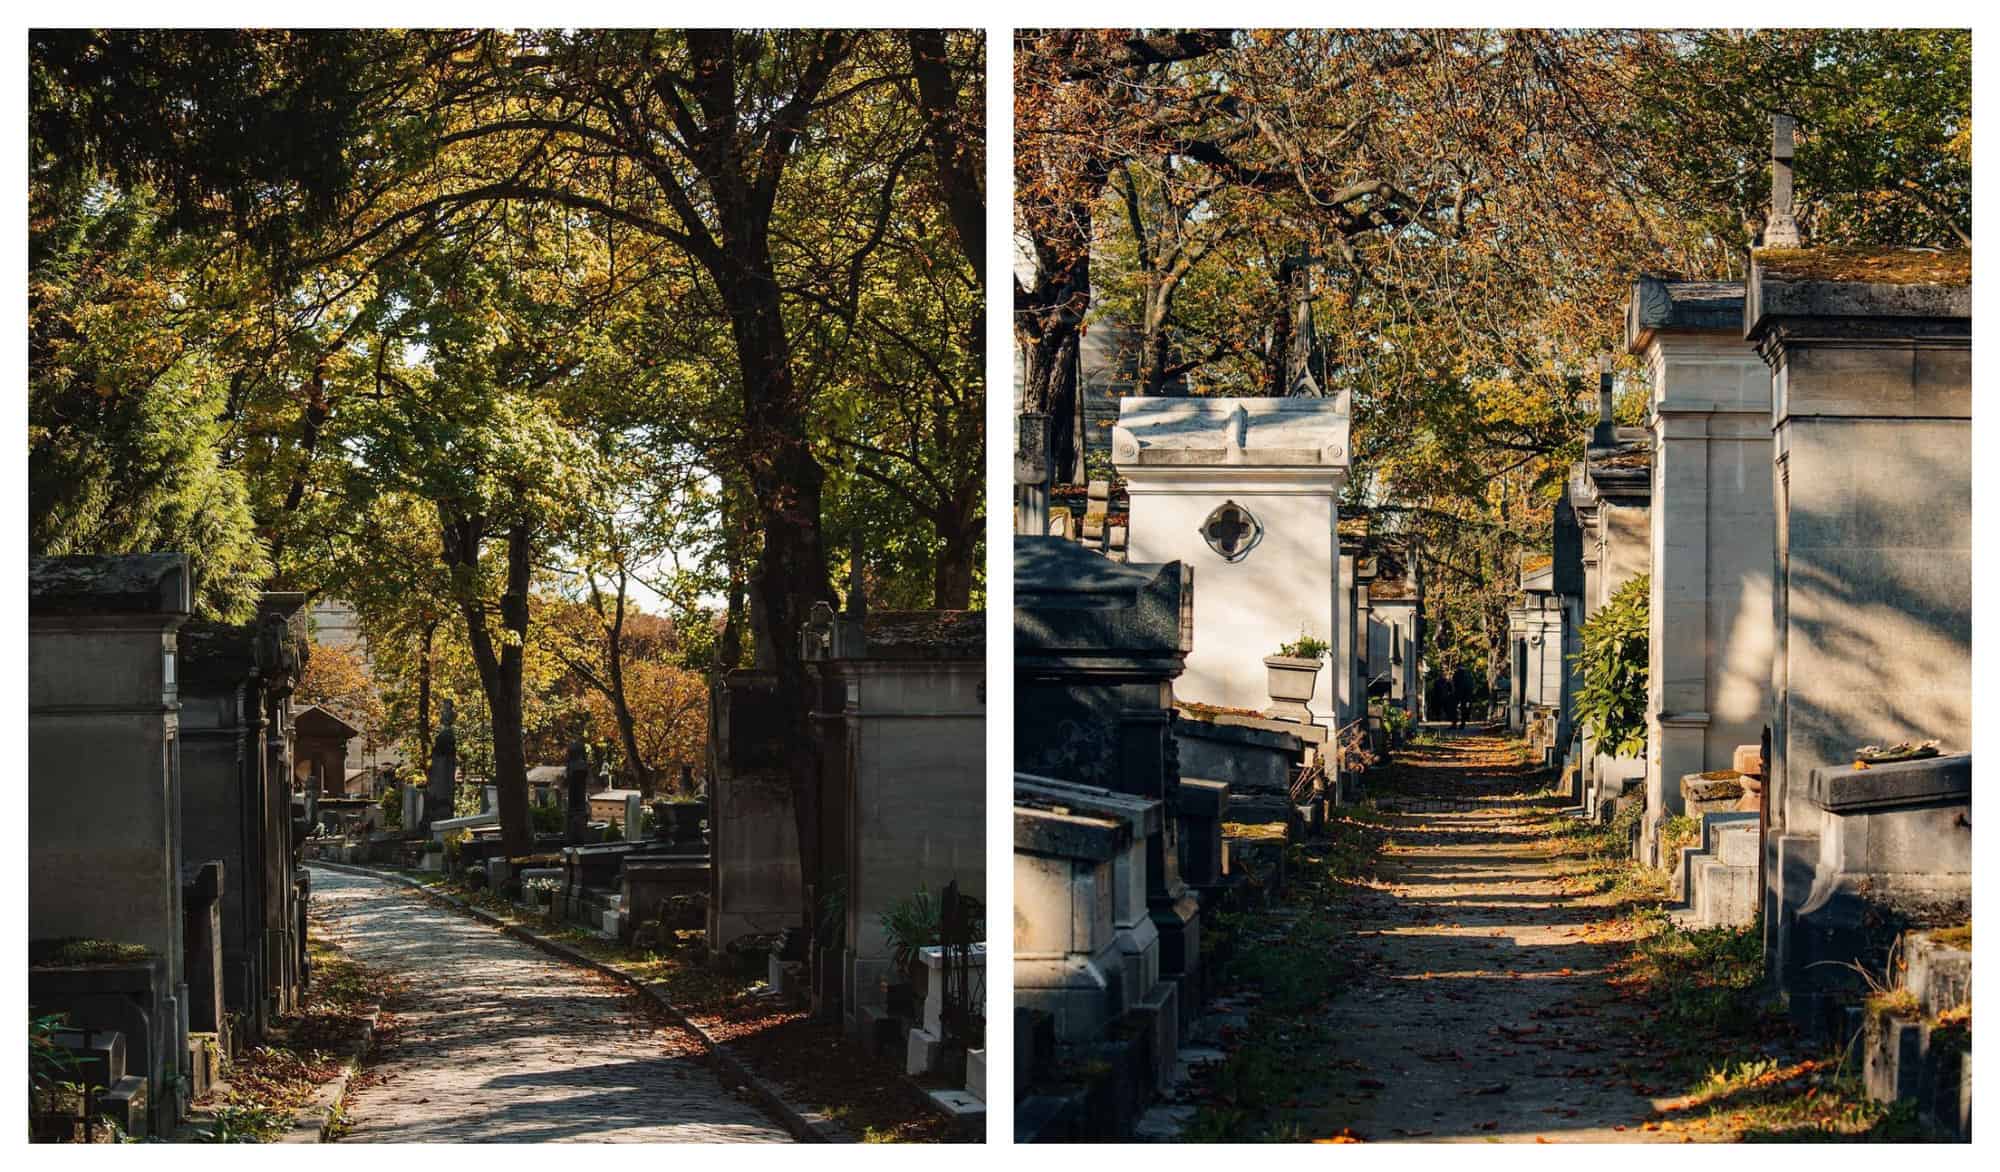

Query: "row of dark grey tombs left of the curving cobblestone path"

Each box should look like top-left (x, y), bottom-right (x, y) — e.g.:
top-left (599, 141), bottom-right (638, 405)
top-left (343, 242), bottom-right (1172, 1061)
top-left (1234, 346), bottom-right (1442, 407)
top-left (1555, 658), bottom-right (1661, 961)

top-left (28, 554), bottom-right (310, 1138)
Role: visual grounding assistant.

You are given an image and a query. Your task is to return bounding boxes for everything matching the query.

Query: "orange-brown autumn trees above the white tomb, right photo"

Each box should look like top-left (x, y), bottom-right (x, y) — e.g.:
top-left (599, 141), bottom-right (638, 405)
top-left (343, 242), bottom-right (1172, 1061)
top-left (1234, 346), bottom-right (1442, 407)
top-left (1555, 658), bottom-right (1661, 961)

top-left (1014, 30), bottom-right (1970, 684)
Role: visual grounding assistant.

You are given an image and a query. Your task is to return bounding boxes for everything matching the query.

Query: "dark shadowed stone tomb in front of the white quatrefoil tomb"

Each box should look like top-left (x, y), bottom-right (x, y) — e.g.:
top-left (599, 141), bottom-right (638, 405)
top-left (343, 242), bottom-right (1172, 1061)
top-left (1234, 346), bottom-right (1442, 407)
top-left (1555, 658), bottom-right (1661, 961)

top-left (1014, 538), bottom-right (1200, 1014)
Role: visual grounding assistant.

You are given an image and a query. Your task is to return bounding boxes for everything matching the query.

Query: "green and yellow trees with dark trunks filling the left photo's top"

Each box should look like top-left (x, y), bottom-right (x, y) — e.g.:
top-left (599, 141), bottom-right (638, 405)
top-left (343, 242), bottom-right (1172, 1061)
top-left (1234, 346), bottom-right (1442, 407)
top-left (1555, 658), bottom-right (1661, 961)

top-left (28, 30), bottom-right (984, 846)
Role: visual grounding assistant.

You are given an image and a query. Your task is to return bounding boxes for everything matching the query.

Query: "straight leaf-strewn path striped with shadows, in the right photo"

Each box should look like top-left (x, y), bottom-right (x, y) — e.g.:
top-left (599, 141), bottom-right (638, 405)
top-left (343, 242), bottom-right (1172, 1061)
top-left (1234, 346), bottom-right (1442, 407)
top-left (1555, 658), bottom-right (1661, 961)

top-left (1310, 732), bottom-right (1688, 1144)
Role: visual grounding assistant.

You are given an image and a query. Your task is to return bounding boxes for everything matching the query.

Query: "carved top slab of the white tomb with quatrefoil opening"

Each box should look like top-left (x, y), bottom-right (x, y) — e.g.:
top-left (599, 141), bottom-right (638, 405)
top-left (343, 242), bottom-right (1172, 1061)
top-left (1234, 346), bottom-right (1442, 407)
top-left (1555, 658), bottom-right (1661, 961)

top-left (1112, 390), bottom-right (1352, 470)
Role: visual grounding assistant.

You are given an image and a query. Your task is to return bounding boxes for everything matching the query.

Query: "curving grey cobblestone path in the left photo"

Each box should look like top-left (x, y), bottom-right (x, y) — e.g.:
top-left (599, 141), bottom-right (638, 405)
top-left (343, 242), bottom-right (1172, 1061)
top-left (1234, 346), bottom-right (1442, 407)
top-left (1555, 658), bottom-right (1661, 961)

top-left (312, 868), bottom-right (790, 1144)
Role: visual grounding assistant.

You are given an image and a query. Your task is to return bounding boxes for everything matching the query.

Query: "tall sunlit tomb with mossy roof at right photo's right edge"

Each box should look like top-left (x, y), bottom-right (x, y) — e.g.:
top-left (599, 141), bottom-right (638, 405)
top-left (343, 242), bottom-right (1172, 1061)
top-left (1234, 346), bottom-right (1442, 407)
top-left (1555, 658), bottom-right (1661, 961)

top-left (1744, 250), bottom-right (1972, 992)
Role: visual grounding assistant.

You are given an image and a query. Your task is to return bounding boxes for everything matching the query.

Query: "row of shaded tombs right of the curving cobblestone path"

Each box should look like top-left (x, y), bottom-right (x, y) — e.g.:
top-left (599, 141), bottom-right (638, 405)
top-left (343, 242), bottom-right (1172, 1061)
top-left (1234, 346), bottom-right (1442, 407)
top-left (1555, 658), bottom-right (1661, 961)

top-left (298, 582), bottom-right (986, 1128)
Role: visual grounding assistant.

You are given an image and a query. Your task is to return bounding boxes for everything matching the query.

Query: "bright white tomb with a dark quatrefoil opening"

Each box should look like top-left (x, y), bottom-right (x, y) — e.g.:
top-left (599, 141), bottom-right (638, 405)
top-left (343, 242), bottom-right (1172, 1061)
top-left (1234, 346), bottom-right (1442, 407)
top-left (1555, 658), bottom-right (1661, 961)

top-left (1112, 392), bottom-right (1350, 724)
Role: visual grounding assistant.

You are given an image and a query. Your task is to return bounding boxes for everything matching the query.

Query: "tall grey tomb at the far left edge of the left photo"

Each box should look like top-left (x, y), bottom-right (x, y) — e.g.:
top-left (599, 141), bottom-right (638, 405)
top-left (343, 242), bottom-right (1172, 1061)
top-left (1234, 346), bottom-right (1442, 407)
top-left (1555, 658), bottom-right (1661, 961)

top-left (26, 554), bottom-right (192, 1130)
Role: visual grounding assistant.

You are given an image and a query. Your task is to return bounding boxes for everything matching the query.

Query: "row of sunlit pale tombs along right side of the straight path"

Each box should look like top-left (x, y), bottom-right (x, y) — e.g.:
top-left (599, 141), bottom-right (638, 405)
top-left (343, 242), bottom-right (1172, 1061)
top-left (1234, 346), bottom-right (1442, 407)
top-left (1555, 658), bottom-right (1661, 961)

top-left (1508, 250), bottom-right (1972, 1132)
